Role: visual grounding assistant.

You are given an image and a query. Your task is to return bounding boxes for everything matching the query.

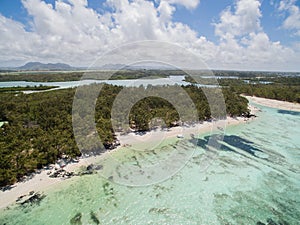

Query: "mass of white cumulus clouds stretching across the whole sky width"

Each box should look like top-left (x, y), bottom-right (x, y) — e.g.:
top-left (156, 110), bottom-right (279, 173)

top-left (0, 0), bottom-right (299, 69)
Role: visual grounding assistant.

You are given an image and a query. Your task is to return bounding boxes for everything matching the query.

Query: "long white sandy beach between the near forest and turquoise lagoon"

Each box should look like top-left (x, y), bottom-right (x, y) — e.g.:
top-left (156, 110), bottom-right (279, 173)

top-left (0, 106), bottom-right (258, 209)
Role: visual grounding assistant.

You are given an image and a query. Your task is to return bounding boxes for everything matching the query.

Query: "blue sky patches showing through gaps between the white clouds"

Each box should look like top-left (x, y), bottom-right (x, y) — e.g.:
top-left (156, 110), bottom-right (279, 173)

top-left (0, 0), bottom-right (288, 44)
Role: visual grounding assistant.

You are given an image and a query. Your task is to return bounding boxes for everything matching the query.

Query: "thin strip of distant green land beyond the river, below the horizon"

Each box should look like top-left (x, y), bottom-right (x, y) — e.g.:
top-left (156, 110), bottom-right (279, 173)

top-left (0, 69), bottom-right (299, 83)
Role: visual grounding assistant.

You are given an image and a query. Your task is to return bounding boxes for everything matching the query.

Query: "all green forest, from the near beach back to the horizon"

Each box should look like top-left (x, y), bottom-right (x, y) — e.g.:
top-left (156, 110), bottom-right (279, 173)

top-left (0, 70), bottom-right (300, 186)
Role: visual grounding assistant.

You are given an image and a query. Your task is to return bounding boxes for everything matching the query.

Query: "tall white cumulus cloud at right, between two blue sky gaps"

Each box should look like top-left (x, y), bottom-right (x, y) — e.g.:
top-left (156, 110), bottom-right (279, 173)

top-left (214, 0), bottom-right (299, 70)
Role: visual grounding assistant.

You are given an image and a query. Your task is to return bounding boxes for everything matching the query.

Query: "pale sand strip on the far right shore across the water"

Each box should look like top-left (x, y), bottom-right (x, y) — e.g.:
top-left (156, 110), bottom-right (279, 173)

top-left (243, 95), bottom-right (300, 112)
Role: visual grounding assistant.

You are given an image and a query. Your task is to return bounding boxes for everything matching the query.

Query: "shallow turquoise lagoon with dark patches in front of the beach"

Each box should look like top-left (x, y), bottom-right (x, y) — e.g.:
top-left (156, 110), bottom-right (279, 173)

top-left (0, 103), bottom-right (300, 225)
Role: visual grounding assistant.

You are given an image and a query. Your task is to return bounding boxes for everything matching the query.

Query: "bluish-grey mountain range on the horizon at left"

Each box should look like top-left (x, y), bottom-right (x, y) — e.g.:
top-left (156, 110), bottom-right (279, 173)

top-left (17, 62), bottom-right (73, 71)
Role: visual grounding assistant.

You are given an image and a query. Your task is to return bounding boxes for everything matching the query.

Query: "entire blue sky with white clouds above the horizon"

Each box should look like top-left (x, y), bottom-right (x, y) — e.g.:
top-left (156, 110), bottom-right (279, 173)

top-left (0, 0), bottom-right (300, 71)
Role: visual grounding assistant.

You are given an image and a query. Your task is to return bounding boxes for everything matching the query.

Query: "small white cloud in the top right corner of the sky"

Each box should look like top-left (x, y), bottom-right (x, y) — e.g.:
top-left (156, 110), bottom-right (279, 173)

top-left (279, 0), bottom-right (300, 36)
